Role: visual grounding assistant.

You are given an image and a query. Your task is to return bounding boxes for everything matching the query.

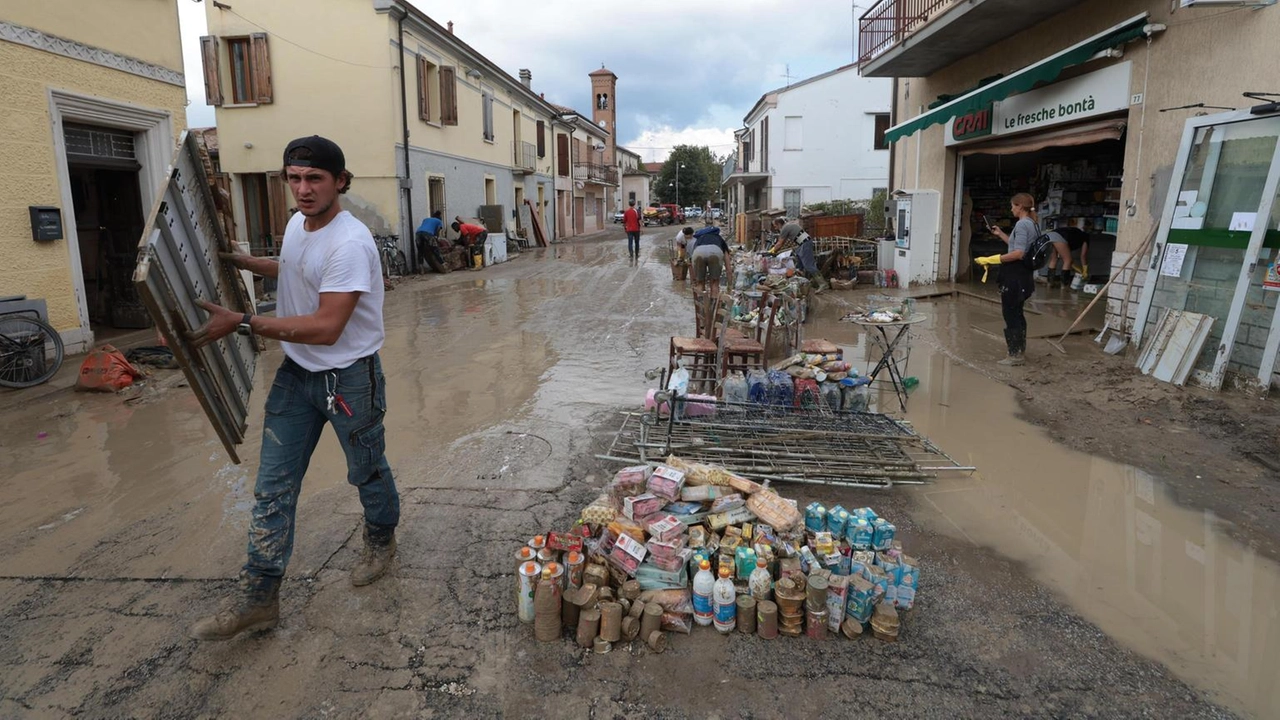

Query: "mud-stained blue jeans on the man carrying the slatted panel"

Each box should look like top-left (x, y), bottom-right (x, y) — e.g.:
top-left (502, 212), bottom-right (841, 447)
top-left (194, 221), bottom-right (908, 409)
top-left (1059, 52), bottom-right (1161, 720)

top-left (244, 354), bottom-right (399, 582)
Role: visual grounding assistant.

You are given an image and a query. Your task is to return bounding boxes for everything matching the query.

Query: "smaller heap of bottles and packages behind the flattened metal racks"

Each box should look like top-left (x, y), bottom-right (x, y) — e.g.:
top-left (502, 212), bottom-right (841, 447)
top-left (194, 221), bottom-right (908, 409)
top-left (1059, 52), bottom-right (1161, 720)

top-left (724, 352), bottom-right (872, 413)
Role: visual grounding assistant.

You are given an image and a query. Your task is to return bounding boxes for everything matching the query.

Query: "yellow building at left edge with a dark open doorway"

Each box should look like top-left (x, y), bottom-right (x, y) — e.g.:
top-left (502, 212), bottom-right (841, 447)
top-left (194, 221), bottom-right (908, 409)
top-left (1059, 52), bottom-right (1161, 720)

top-left (0, 0), bottom-right (187, 352)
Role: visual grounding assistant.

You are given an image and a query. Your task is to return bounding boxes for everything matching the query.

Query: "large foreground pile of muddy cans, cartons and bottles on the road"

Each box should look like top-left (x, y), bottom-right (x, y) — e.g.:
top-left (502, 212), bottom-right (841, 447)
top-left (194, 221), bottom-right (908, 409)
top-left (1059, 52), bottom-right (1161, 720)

top-left (516, 456), bottom-right (920, 653)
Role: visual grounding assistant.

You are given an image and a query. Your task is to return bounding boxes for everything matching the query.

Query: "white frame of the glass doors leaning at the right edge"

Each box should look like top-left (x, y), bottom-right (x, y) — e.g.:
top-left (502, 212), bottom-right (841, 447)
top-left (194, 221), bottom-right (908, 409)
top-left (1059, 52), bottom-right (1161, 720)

top-left (1121, 109), bottom-right (1280, 389)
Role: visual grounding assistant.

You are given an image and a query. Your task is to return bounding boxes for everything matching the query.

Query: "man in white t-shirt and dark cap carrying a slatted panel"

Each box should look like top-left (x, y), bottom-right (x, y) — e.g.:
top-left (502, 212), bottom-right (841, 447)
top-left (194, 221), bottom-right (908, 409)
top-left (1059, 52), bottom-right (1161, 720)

top-left (189, 136), bottom-right (399, 639)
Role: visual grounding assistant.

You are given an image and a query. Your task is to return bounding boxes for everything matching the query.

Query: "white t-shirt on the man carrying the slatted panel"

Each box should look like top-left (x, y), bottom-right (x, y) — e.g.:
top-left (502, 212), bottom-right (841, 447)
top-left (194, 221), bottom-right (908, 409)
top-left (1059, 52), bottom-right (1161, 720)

top-left (276, 210), bottom-right (387, 372)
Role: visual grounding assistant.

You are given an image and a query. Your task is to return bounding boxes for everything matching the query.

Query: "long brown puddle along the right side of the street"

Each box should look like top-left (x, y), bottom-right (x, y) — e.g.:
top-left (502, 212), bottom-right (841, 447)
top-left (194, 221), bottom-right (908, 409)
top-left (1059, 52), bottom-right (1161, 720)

top-left (818, 297), bottom-right (1280, 717)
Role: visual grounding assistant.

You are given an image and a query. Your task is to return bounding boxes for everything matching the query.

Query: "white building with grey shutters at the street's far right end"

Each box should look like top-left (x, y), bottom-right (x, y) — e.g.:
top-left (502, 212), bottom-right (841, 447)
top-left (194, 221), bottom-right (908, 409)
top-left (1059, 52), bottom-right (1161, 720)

top-left (724, 64), bottom-right (893, 217)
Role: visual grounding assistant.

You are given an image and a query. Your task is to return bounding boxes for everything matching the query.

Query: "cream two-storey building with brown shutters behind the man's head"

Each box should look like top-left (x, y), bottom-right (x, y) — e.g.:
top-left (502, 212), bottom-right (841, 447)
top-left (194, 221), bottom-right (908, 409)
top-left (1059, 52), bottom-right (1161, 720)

top-left (202, 0), bottom-right (558, 263)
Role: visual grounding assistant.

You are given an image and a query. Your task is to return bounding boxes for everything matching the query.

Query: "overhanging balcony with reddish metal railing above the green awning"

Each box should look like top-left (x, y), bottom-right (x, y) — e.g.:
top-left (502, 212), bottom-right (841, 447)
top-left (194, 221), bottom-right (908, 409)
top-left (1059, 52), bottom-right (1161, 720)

top-left (858, 0), bottom-right (1083, 77)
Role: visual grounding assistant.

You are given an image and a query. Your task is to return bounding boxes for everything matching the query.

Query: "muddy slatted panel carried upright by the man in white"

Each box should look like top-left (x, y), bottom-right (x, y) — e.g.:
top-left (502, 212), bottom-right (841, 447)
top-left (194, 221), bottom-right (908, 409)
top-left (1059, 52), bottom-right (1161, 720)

top-left (133, 132), bottom-right (257, 464)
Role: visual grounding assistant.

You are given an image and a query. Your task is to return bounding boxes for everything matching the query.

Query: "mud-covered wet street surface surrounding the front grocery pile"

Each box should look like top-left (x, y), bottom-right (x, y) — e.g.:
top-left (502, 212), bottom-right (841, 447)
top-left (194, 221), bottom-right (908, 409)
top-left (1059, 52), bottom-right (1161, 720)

top-left (0, 231), bottom-right (1280, 717)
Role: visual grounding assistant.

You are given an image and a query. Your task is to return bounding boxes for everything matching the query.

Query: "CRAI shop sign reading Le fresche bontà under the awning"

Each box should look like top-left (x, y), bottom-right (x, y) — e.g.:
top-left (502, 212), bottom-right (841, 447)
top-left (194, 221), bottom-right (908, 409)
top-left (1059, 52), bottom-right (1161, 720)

top-left (946, 63), bottom-right (1133, 146)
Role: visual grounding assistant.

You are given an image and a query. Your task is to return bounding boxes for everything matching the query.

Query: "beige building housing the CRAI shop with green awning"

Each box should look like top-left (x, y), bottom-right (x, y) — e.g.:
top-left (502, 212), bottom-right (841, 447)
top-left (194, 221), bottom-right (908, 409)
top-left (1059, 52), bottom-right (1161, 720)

top-left (859, 0), bottom-right (1280, 384)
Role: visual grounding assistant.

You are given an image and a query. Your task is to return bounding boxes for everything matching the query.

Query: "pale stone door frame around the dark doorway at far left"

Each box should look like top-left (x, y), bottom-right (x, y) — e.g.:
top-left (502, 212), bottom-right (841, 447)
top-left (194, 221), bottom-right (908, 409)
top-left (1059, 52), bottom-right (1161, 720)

top-left (49, 88), bottom-right (174, 354)
